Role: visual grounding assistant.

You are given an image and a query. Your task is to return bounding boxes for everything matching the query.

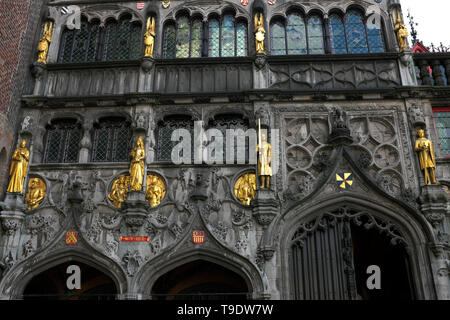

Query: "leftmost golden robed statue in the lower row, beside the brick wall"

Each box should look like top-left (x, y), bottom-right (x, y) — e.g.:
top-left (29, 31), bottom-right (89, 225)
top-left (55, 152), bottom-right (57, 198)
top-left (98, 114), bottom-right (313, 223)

top-left (6, 139), bottom-right (30, 193)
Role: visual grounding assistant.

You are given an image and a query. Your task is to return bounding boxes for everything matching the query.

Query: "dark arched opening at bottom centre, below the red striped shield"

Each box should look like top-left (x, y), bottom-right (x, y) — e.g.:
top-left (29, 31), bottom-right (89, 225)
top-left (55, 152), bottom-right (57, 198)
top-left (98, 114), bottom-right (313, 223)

top-left (152, 260), bottom-right (248, 300)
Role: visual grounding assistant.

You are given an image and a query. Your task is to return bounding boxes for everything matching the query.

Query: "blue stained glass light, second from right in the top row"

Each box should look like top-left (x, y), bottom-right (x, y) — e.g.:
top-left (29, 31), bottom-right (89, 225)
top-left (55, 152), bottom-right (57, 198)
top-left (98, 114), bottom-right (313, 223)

top-left (345, 11), bottom-right (369, 53)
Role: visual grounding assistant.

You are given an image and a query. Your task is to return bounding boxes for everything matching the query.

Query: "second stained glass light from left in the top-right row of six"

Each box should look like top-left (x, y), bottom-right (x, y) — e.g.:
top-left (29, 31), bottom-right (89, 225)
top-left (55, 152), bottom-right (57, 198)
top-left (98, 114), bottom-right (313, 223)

top-left (286, 13), bottom-right (307, 54)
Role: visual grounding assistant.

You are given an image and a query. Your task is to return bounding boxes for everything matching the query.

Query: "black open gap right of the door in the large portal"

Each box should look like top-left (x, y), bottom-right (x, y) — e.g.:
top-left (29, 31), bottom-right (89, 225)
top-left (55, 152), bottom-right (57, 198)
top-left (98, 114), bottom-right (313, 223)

top-left (351, 225), bottom-right (415, 300)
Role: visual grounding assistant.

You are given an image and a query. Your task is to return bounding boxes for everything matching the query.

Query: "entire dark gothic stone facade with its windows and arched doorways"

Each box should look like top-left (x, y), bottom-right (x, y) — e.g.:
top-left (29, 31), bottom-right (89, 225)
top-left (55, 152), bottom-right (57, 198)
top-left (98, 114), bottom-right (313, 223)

top-left (0, 0), bottom-right (450, 299)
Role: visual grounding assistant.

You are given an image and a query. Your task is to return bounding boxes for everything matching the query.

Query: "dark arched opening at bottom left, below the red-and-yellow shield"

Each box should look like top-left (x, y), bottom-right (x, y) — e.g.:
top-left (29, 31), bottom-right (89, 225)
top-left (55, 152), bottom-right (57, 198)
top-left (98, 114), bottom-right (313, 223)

top-left (23, 261), bottom-right (117, 300)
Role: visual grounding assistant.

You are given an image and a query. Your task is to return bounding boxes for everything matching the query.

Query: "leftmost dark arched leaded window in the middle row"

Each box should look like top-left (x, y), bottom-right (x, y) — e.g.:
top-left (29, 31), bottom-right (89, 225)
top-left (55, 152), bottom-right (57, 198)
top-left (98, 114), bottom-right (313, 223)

top-left (44, 119), bottom-right (82, 163)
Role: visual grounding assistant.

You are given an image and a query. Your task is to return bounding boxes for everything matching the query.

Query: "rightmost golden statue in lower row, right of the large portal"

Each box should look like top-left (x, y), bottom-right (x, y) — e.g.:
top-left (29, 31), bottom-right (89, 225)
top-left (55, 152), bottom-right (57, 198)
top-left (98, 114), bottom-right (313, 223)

top-left (414, 129), bottom-right (439, 184)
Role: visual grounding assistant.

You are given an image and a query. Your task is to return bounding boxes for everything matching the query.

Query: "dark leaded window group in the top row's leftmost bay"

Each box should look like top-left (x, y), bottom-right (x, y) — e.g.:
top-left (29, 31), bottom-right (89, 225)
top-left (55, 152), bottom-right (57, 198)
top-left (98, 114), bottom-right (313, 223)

top-left (58, 15), bottom-right (142, 63)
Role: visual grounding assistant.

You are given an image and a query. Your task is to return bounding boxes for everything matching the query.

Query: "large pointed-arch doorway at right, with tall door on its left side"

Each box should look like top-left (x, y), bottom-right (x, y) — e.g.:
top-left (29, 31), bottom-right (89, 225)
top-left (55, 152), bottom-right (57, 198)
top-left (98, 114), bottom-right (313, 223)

top-left (289, 207), bottom-right (415, 300)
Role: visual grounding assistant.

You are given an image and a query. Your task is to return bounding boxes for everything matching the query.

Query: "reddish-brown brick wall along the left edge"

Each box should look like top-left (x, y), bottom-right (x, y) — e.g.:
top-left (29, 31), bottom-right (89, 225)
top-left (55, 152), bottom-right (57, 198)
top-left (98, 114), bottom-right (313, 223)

top-left (0, 0), bottom-right (45, 196)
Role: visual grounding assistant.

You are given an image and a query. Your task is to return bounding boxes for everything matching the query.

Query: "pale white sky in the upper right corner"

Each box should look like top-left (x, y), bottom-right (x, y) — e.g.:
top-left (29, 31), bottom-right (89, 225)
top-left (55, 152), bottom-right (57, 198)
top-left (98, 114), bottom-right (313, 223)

top-left (400, 0), bottom-right (450, 46)
